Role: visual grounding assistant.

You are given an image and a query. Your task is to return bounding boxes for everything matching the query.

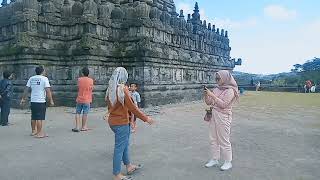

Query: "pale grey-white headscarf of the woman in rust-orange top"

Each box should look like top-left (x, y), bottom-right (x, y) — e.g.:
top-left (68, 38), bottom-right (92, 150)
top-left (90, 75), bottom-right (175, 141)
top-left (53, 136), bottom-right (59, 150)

top-left (106, 67), bottom-right (128, 106)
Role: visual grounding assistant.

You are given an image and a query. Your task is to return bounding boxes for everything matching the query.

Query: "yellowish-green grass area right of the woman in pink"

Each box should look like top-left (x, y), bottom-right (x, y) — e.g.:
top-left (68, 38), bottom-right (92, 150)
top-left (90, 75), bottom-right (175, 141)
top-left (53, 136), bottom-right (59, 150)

top-left (234, 91), bottom-right (320, 129)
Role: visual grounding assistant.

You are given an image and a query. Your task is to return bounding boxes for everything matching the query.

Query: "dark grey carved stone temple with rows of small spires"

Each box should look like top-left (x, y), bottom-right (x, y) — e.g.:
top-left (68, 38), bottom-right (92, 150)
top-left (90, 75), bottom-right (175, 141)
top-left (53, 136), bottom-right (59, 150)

top-left (0, 0), bottom-right (238, 106)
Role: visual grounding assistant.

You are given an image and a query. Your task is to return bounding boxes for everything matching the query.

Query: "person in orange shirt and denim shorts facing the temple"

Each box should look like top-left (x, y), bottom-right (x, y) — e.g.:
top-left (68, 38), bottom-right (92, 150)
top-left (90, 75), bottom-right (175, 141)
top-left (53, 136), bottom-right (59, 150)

top-left (72, 67), bottom-right (93, 132)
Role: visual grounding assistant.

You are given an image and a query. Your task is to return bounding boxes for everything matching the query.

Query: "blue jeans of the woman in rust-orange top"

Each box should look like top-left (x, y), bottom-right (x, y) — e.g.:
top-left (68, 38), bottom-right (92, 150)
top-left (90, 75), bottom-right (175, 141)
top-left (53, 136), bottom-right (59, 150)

top-left (110, 124), bottom-right (131, 176)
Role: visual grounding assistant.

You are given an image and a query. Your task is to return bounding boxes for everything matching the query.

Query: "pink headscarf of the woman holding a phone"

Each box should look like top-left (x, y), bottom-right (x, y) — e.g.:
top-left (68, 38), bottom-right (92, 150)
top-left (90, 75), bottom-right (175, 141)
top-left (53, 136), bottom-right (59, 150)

top-left (216, 70), bottom-right (239, 101)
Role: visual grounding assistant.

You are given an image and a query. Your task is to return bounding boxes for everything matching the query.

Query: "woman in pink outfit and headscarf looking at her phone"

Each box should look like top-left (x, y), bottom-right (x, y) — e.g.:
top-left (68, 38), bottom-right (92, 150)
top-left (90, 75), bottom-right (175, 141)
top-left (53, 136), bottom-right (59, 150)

top-left (204, 70), bottom-right (239, 170)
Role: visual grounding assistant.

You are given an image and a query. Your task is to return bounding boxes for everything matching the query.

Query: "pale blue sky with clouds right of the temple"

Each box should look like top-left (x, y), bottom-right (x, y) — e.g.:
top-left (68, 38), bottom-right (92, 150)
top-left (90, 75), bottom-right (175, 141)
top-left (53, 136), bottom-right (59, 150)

top-left (174, 0), bottom-right (320, 74)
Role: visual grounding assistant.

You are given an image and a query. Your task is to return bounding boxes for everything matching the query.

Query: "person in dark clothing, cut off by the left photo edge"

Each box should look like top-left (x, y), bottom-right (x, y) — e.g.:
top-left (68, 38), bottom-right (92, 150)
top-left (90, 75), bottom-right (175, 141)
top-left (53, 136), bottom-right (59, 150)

top-left (0, 71), bottom-right (13, 126)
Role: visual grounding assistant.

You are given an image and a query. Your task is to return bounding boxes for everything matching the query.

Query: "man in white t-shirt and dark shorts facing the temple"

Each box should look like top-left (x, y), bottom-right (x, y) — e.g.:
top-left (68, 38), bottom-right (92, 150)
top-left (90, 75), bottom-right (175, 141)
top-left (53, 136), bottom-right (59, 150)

top-left (20, 66), bottom-right (54, 138)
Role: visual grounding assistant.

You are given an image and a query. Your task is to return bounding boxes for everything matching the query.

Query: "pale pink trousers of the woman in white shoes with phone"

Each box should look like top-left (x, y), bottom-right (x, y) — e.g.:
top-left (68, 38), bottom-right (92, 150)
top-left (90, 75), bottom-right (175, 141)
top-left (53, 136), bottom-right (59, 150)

top-left (209, 110), bottom-right (232, 161)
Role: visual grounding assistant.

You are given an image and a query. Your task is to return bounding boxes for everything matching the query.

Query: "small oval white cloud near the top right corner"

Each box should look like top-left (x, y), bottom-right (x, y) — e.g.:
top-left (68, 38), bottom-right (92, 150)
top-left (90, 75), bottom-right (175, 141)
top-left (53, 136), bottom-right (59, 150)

top-left (263, 5), bottom-right (298, 21)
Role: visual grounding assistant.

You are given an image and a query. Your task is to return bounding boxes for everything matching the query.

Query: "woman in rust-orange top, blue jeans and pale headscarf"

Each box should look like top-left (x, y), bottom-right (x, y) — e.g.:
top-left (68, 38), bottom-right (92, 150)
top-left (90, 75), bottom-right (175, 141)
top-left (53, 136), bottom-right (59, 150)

top-left (105, 67), bottom-right (154, 180)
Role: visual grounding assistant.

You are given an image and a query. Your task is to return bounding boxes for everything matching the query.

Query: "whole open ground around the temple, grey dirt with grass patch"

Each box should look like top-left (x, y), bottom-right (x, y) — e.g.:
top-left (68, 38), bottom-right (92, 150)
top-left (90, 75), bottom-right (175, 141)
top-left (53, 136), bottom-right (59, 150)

top-left (0, 92), bottom-right (320, 180)
